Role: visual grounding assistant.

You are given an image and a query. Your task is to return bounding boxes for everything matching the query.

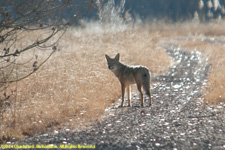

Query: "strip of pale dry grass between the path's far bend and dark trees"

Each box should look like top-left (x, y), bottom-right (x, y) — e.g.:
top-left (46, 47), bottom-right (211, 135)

top-left (147, 20), bottom-right (225, 38)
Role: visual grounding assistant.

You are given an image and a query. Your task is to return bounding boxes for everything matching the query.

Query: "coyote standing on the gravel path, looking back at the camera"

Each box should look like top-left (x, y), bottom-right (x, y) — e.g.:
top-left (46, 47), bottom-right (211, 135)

top-left (105, 53), bottom-right (152, 107)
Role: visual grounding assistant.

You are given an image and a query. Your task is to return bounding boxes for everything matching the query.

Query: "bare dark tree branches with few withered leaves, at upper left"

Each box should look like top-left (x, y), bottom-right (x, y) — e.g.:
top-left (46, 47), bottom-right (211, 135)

top-left (0, 0), bottom-right (92, 85)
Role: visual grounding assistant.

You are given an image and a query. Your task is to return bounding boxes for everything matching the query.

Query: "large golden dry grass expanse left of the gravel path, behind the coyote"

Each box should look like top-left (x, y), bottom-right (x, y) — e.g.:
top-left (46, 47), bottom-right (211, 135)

top-left (0, 25), bottom-right (171, 139)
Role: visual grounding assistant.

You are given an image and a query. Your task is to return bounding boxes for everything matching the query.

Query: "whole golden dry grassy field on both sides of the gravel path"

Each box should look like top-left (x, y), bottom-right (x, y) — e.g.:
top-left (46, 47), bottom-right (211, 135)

top-left (0, 22), bottom-right (225, 142)
